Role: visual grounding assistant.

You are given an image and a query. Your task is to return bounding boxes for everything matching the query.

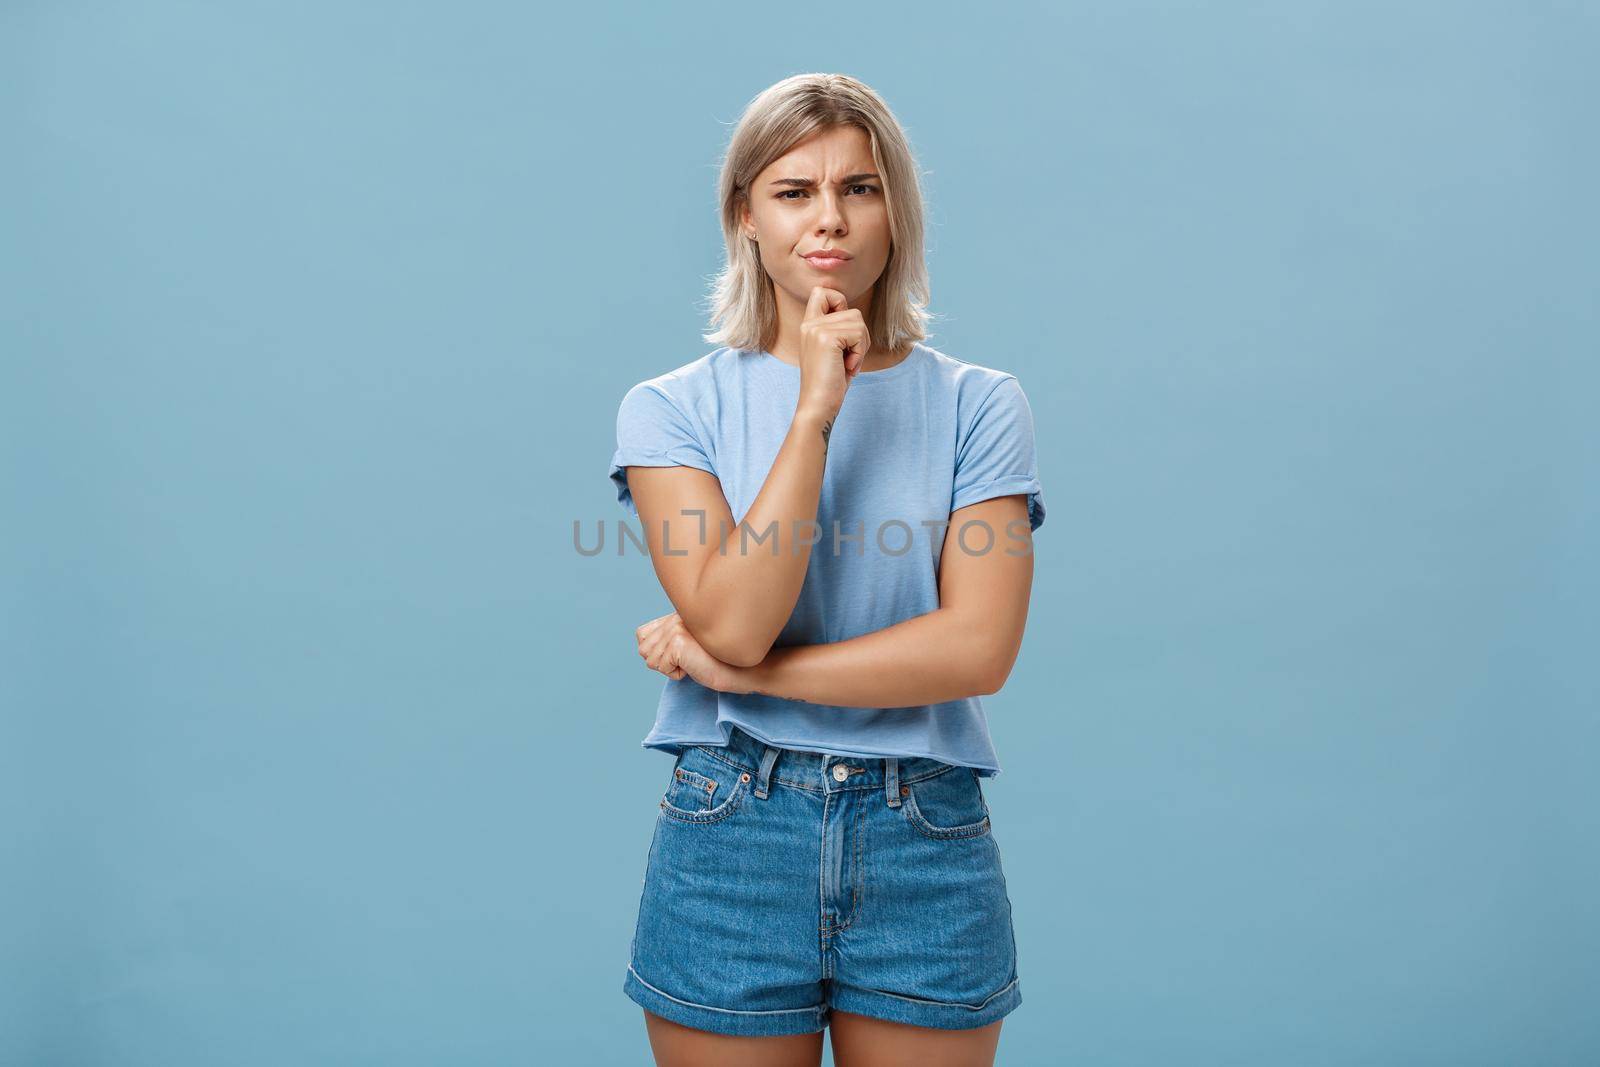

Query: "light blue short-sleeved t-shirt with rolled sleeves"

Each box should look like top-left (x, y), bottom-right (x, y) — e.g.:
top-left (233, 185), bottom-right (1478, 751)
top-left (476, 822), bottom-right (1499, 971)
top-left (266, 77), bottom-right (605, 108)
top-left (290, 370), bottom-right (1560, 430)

top-left (610, 344), bottom-right (1045, 777)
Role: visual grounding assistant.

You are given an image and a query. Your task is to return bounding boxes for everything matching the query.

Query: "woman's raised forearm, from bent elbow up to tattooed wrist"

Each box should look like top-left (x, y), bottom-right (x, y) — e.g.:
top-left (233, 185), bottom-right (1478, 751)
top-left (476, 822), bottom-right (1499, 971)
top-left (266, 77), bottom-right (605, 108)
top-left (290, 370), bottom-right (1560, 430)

top-left (691, 408), bottom-right (834, 665)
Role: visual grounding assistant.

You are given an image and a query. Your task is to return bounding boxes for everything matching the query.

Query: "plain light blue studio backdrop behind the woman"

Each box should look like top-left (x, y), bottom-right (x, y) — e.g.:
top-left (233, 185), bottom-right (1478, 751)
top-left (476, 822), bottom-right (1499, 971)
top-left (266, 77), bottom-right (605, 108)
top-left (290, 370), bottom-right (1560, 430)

top-left (0, 0), bottom-right (1600, 1067)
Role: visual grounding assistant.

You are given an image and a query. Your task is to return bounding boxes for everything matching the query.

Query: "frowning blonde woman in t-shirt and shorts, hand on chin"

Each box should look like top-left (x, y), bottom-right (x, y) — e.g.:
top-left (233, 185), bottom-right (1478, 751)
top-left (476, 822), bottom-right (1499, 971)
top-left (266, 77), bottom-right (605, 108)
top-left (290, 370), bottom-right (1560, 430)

top-left (611, 74), bottom-right (1045, 1067)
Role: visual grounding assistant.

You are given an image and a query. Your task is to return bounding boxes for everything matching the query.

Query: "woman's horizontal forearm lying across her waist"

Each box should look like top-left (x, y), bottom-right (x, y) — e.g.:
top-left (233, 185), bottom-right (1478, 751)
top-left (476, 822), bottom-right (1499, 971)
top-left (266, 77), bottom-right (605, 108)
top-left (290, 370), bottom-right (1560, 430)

top-left (731, 608), bottom-right (1008, 707)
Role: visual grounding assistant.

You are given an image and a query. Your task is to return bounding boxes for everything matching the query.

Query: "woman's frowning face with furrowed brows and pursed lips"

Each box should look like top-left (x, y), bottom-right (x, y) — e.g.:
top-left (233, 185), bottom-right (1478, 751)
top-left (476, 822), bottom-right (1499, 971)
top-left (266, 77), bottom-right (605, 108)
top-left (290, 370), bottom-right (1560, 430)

top-left (742, 126), bottom-right (890, 307)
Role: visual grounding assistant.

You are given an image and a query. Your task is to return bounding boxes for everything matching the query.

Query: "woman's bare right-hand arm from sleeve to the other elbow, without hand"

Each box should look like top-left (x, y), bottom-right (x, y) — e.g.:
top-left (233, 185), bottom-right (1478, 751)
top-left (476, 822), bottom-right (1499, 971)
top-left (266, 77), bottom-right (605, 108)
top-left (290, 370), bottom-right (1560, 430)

top-left (720, 496), bottom-right (1034, 707)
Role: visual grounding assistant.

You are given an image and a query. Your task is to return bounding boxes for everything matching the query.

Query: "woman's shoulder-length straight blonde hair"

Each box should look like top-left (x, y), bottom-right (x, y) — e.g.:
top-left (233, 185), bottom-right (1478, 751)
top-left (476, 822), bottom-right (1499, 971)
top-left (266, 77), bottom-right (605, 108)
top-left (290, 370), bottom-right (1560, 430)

top-left (702, 74), bottom-right (933, 352)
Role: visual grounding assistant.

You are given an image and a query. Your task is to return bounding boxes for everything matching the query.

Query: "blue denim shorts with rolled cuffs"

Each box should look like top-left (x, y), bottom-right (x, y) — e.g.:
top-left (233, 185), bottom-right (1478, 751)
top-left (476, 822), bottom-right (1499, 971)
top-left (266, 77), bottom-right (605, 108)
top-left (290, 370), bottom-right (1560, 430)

top-left (622, 728), bottom-right (1022, 1035)
